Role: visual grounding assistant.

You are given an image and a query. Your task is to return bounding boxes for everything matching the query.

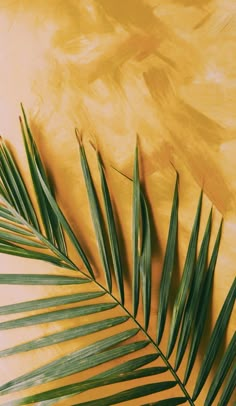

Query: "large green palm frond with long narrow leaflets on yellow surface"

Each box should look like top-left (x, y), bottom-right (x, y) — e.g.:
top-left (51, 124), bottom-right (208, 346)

top-left (0, 107), bottom-right (236, 406)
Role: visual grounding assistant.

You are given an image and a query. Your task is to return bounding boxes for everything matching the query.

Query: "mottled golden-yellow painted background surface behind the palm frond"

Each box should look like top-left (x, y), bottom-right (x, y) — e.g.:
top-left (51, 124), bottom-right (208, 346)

top-left (0, 0), bottom-right (236, 405)
